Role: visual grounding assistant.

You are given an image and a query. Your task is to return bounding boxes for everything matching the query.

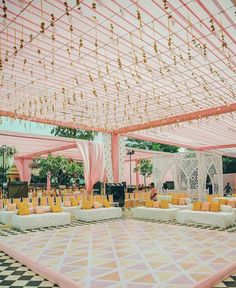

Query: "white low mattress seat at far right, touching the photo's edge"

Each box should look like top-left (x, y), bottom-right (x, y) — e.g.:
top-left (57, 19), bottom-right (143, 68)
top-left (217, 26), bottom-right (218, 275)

top-left (176, 210), bottom-right (235, 228)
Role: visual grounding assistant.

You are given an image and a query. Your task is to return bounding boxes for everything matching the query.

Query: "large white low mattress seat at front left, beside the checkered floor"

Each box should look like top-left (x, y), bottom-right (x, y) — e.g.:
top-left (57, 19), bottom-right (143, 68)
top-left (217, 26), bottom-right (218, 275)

top-left (12, 212), bottom-right (70, 230)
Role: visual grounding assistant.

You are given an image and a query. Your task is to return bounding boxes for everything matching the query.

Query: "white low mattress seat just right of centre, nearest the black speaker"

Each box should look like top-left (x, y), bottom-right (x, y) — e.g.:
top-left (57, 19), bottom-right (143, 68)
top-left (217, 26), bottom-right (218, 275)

top-left (133, 207), bottom-right (179, 221)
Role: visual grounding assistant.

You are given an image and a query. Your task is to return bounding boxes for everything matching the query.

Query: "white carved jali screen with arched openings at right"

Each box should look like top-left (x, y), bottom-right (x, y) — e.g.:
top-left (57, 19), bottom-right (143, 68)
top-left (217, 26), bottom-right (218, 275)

top-left (153, 151), bottom-right (223, 200)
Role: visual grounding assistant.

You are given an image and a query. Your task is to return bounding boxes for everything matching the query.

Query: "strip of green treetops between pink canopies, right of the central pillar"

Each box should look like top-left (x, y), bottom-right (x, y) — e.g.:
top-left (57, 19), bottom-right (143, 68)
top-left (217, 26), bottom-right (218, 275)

top-left (126, 138), bottom-right (179, 153)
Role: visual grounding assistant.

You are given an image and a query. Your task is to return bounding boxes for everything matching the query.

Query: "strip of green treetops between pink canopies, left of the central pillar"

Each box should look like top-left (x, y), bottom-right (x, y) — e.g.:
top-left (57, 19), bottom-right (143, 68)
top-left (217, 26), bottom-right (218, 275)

top-left (51, 126), bottom-right (97, 140)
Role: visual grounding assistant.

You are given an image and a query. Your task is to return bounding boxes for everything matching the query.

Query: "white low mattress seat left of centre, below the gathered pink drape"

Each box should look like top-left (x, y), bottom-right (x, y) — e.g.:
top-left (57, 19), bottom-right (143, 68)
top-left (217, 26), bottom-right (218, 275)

top-left (74, 207), bottom-right (122, 222)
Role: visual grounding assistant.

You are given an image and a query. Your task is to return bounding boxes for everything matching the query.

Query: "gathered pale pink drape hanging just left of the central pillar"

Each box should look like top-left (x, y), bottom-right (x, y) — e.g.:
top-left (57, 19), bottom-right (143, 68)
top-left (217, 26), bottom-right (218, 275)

top-left (76, 141), bottom-right (105, 193)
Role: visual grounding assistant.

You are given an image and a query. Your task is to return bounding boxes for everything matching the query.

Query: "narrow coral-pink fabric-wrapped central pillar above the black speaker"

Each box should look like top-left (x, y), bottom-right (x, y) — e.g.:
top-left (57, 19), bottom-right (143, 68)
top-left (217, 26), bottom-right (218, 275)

top-left (111, 134), bottom-right (120, 183)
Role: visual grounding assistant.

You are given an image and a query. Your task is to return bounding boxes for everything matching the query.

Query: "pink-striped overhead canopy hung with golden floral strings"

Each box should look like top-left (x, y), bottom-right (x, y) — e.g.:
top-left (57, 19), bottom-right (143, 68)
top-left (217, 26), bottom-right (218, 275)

top-left (0, 0), bottom-right (236, 131)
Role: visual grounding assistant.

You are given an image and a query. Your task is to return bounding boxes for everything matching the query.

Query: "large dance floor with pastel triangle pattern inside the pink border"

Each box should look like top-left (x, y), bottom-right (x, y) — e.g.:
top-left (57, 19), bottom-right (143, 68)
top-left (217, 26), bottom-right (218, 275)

top-left (0, 219), bottom-right (236, 288)
